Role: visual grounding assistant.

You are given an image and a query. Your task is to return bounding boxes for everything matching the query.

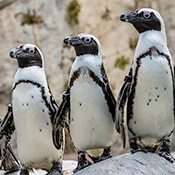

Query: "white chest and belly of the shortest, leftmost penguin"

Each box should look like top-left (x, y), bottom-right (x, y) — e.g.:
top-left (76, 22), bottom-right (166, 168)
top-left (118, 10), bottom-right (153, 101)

top-left (12, 83), bottom-right (62, 165)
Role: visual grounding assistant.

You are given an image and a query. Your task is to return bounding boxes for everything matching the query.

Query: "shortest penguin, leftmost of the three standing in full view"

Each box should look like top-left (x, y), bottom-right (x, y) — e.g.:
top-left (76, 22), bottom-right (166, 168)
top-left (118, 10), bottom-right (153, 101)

top-left (10, 44), bottom-right (64, 175)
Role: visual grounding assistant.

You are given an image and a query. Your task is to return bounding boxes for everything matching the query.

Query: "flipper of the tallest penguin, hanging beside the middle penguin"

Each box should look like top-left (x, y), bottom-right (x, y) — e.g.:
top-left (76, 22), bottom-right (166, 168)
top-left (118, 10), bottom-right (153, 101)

top-left (115, 72), bottom-right (132, 148)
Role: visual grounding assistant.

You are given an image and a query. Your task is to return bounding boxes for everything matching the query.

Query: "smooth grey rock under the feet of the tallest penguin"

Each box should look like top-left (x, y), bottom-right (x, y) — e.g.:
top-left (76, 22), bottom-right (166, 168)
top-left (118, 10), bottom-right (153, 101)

top-left (75, 152), bottom-right (175, 175)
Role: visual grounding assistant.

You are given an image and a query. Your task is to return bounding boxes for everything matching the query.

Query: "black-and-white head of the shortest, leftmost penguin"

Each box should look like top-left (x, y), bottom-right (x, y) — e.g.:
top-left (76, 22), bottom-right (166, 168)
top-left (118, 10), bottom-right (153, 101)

top-left (9, 44), bottom-right (44, 68)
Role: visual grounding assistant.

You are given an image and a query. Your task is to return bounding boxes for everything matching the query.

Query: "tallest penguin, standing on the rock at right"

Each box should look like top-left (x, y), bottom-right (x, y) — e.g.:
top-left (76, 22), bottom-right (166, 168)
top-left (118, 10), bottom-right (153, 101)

top-left (116, 8), bottom-right (175, 162)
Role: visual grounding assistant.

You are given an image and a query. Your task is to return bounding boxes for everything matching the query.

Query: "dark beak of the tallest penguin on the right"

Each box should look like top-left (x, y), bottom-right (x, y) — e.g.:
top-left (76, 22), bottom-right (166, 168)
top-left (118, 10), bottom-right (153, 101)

top-left (120, 12), bottom-right (140, 24)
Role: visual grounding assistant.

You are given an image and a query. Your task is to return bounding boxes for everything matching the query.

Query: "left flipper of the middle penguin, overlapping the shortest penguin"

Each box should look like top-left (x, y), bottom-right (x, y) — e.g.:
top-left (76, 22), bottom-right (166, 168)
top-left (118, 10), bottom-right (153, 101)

top-left (52, 89), bottom-right (70, 149)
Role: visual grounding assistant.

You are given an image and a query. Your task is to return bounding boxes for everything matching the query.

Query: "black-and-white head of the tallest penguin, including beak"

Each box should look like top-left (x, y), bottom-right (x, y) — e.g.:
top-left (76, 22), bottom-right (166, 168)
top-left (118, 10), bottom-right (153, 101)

top-left (120, 8), bottom-right (165, 33)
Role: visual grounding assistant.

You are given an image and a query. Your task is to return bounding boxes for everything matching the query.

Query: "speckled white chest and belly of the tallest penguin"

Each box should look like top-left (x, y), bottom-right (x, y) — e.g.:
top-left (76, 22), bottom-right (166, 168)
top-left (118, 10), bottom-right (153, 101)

top-left (129, 55), bottom-right (174, 139)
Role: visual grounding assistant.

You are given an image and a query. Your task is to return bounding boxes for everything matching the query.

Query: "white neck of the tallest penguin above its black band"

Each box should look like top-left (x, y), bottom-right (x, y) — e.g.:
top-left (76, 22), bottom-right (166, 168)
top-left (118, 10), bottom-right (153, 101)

top-left (135, 30), bottom-right (168, 58)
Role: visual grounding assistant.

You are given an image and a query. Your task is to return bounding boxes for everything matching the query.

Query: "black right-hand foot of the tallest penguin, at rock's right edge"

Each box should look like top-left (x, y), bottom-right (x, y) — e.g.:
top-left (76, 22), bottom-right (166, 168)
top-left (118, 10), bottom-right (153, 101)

top-left (158, 140), bottom-right (175, 163)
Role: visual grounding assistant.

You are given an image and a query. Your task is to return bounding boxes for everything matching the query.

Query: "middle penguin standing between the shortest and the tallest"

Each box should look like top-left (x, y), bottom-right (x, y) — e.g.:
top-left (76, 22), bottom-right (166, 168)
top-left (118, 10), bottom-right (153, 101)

top-left (54, 33), bottom-right (116, 172)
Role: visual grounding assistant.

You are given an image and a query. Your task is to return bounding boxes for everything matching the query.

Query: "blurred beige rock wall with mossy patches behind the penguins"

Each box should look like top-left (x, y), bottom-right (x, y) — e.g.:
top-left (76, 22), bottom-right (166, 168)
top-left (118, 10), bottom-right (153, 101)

top-left (0, 0), bottom-right (175, 159)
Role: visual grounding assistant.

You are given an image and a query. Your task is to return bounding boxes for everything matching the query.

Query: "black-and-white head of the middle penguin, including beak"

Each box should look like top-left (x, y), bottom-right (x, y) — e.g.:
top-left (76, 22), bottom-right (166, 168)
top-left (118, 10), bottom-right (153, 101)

top-left (64, 33), bottom-right (101, 56)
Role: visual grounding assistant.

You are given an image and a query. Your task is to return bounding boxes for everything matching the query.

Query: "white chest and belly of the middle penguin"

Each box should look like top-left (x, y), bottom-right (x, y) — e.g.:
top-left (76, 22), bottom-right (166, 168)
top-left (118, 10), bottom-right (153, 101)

top-left (70, 74), bottom-right (115, 150)
